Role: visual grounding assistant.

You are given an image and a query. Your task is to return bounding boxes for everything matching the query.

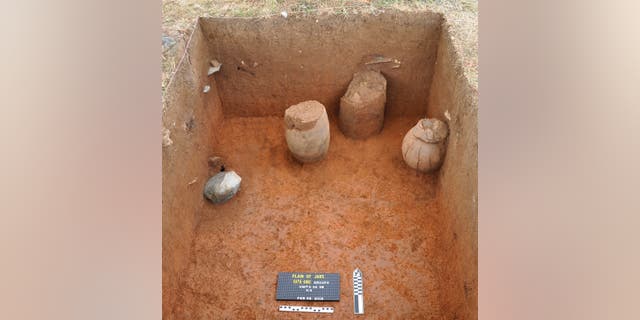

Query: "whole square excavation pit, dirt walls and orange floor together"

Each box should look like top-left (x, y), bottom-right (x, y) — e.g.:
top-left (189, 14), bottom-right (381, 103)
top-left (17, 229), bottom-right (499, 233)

top-left (163, 11), bottom-right (477, 319)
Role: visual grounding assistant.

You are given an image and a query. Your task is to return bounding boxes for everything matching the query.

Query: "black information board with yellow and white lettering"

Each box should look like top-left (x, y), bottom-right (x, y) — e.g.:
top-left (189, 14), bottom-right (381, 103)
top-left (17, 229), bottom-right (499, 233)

top-left (276, 272), bottom-right (340, 301)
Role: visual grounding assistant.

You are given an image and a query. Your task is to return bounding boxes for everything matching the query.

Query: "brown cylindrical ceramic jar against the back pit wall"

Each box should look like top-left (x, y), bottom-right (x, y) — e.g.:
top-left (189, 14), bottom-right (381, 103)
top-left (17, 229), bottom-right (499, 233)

top-left (339, 70), bottom-right (387, 139)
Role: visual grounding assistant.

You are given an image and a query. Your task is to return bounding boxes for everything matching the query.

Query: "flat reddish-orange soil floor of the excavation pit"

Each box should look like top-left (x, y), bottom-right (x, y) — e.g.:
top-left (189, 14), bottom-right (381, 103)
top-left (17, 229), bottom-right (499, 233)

top-left (174, 117), bottom-right (446, 319)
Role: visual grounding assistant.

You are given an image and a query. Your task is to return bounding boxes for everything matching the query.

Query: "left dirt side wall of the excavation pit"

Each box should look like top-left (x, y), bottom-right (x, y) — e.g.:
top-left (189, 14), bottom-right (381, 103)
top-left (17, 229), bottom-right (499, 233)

top-left (162, 21), bottom-right (223, 319)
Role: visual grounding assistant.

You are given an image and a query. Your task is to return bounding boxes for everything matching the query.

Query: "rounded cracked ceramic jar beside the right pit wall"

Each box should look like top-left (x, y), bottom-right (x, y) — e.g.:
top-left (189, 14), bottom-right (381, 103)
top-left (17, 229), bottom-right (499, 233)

top-left (402, 119), bottom-right (448, 172)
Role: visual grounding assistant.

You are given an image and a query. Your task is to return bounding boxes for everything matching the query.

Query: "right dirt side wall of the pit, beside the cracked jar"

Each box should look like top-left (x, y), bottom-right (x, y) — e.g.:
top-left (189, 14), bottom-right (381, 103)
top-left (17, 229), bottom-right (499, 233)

top-left (427, 22), bottom-right (478, 319)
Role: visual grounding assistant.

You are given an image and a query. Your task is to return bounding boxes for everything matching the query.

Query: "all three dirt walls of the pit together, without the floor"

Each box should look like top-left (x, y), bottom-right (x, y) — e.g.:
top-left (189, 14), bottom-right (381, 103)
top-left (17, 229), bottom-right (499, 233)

top-left (162, 11), bottom-right (478, 319)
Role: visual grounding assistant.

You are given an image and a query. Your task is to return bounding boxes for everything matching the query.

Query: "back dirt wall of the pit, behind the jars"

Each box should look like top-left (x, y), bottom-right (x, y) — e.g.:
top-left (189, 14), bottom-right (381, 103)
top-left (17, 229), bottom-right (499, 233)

top-left (202, 11), bottom-right (442, 117)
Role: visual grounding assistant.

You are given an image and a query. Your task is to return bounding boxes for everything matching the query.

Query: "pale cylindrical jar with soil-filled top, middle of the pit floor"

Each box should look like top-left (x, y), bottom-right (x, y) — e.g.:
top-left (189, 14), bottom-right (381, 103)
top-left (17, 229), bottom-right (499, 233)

top-left (284, 100), bottom-right (329, 163)
